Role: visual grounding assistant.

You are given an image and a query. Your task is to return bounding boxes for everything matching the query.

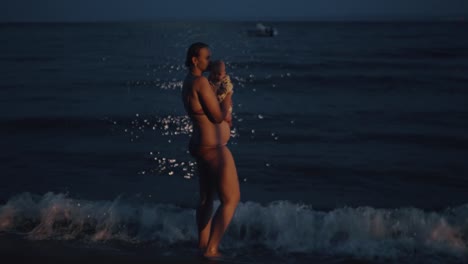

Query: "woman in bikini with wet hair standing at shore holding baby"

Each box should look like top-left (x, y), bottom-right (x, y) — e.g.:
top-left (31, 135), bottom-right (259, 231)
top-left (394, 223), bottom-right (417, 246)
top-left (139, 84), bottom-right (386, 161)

top-left (182, 42), bottom-right (240, 258)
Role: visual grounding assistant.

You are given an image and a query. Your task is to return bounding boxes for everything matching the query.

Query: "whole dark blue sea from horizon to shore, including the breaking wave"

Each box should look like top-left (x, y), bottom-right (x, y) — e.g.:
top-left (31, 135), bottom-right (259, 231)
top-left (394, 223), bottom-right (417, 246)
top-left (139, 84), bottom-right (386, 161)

top-left (0, 22), bottom-right (468, 263)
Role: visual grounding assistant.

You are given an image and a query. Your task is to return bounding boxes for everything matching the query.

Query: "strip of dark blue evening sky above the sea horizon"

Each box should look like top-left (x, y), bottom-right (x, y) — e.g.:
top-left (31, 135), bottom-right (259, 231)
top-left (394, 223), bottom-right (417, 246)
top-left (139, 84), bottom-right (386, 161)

top-left (0, 0), bottom-right (468, 22)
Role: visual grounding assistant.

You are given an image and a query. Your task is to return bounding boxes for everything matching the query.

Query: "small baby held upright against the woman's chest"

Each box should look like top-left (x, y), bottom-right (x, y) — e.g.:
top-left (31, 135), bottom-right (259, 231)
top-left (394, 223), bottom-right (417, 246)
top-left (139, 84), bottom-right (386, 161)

top-left (208, 60), bottom-right (234, 127)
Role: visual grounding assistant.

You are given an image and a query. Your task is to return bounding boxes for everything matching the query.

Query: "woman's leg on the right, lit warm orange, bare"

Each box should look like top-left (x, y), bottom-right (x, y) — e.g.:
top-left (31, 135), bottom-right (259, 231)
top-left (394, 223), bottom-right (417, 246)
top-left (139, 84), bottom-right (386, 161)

top-left (205, 146), bottom-right (240, 256)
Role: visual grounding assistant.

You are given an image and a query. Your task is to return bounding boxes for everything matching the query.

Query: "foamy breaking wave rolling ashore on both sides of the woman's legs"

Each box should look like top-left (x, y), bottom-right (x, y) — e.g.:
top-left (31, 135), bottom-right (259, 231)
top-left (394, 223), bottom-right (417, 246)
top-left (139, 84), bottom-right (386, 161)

top-left (0, 193), bottom-right (468, 258)
